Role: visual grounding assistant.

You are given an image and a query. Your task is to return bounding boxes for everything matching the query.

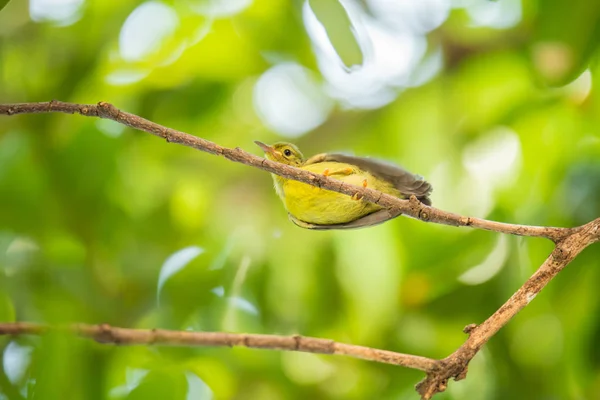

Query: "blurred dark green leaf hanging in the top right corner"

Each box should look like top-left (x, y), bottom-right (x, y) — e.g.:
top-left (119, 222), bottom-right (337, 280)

top-left (532, 0), bottom-right (600, 86)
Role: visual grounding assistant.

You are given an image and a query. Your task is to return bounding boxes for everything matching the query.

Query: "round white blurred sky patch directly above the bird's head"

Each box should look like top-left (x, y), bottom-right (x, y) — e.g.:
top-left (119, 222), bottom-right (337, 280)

top-left (254, 63), bottom-right (333, 138)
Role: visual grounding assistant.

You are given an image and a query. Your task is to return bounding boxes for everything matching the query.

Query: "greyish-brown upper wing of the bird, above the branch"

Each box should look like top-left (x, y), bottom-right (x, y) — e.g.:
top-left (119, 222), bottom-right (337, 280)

top-left (305, 153), bottom-right (432, 205)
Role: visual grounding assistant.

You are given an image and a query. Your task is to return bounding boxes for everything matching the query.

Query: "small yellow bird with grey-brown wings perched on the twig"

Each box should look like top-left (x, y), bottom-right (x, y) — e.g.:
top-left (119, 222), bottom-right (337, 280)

top-left (255, 141), bottom-right (432, 230)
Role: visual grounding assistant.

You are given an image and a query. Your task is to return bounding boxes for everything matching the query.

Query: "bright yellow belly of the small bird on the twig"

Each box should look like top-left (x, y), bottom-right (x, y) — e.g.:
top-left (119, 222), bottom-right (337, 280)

top-left (276, 162), bottom-right (399, 225)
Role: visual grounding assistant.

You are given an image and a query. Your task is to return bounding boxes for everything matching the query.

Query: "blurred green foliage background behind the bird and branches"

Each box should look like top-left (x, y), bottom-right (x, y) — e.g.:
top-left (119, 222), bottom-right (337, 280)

top-left (0, 0), bottom-right (600, 400)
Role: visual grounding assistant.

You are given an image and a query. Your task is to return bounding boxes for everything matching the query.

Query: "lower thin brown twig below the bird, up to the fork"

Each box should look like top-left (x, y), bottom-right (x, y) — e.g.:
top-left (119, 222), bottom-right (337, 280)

top-left (0, 322), bottom-right (437, 372)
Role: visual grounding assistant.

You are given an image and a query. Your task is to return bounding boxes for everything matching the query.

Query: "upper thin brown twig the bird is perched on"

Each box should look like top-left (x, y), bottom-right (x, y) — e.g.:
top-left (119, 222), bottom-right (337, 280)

top-left (0, 100), bottom-right (571, 242)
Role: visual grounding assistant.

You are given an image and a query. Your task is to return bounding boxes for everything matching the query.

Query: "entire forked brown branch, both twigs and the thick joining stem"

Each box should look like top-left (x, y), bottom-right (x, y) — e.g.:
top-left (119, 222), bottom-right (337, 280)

top-left (0, 101), bottom-right (600, 399)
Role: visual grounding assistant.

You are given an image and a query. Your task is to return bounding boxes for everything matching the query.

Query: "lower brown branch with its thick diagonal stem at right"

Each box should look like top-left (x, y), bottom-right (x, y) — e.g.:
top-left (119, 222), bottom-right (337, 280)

top-left (0, 211), bottom-right (600, 400)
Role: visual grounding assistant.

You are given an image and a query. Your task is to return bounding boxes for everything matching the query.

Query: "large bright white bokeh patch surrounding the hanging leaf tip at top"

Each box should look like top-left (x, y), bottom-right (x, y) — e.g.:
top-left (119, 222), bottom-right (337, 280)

top-left (303, 1), bottom-right (440, 108)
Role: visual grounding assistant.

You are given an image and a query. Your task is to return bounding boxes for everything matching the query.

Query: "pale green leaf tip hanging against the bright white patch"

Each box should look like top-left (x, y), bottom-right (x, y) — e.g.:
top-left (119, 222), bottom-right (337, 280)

top-left (309, 0), bottom-right (363, 68)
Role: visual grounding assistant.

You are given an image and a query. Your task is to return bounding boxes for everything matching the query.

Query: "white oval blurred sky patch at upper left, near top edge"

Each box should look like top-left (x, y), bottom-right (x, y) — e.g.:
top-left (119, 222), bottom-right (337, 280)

top-left (119, 1), bottom-right (179, 61)
